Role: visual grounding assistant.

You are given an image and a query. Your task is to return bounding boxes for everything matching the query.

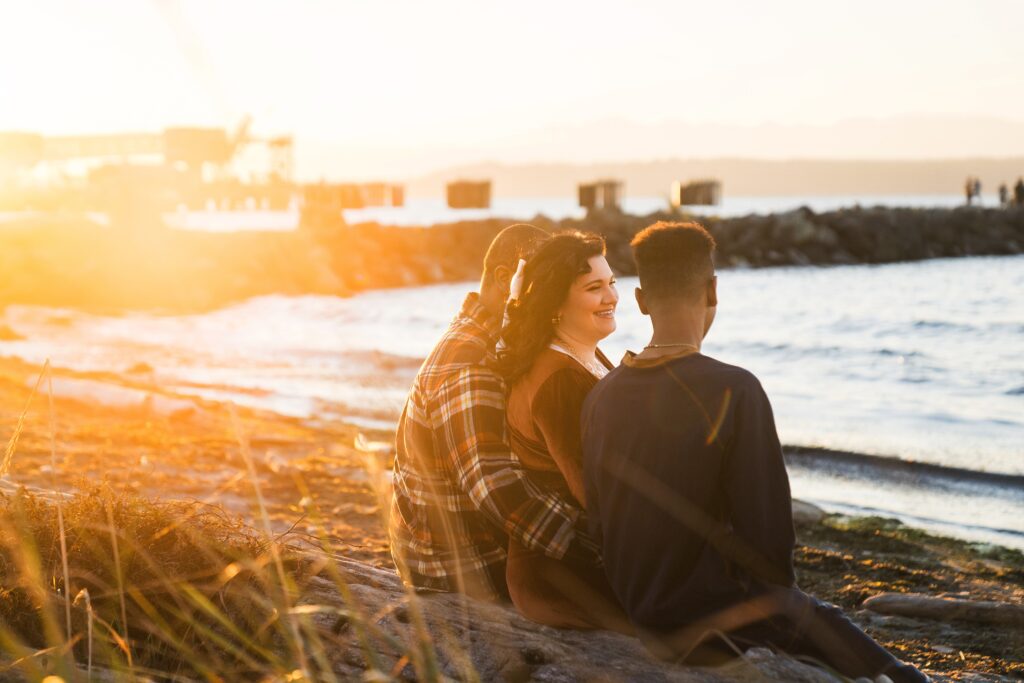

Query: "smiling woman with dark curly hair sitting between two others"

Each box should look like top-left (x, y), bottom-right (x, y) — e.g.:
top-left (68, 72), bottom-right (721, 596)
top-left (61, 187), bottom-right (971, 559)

top-left (498, 231), bottom-right (631, 632)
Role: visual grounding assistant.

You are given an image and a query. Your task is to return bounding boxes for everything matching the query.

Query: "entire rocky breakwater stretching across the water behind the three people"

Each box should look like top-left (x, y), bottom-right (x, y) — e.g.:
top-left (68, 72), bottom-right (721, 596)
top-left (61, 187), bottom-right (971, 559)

top-left (0, 207), bottom-right (1024, 312)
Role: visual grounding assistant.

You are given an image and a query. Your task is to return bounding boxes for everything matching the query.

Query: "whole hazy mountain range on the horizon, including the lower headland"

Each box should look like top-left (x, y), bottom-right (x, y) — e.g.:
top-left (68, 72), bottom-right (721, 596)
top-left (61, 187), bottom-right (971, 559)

top-left (296, 117), bottom-right (1024, 197)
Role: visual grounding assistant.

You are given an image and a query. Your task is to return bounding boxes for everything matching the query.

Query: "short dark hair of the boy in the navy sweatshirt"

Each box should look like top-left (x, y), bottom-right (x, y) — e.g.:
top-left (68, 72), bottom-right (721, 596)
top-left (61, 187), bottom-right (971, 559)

top-left (630, 221), bottom-right (715, 300)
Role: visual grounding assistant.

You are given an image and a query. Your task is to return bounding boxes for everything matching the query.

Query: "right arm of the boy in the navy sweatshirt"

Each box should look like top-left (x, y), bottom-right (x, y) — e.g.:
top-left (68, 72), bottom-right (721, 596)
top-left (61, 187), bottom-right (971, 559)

top-left (725, 378), bottom-right (796, 585)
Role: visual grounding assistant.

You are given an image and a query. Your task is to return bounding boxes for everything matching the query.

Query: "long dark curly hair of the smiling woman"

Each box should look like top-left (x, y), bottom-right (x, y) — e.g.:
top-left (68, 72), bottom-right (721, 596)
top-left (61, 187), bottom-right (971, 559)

top-left (498, 230), bottom-right (604, 387)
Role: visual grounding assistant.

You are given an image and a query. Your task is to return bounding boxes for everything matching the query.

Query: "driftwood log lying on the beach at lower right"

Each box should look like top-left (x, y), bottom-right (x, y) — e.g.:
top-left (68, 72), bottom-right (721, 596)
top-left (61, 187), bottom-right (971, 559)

top-left (862, 593), bottom-right (1024, 626)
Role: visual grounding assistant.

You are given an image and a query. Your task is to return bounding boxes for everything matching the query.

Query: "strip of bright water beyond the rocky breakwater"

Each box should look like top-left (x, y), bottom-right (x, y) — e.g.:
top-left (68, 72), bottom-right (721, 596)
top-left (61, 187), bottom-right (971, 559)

top-left (153, 195), bottom-right (997, 232)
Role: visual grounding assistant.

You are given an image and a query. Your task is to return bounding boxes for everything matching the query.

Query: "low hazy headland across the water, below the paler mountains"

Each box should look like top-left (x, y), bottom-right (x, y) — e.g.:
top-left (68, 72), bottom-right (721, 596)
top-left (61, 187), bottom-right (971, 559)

top-left (407, 156), bottom-right (1024, 197)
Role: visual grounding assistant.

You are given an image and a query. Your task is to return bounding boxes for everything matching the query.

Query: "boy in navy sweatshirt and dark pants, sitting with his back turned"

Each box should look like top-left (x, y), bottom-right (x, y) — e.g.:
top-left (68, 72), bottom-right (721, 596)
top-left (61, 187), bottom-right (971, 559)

top-left (582, 223), bottom-right (928, 681)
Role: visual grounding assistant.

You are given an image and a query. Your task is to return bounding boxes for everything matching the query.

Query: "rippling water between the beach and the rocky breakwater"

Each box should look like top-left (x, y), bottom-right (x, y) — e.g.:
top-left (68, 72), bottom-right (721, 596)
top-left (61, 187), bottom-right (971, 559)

top-left (0, 256), bottom-right (1024, 548)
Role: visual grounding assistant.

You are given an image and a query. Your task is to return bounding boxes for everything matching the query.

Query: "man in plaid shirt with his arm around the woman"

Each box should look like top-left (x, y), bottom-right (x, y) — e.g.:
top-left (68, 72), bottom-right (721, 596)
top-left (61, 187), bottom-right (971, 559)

top-left (388, 224), bottom-right (598, 600)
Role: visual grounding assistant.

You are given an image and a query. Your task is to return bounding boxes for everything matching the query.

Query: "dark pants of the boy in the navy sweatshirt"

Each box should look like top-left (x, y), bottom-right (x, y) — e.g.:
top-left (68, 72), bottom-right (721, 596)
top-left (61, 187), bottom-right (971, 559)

top-left (657, 588), bottom-right (928, 683)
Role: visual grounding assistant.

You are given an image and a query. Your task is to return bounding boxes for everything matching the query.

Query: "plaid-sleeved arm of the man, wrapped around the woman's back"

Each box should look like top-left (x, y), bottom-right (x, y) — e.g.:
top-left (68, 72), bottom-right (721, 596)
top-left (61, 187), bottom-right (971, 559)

top-left (434, 368), bottom-right (598, 562)
